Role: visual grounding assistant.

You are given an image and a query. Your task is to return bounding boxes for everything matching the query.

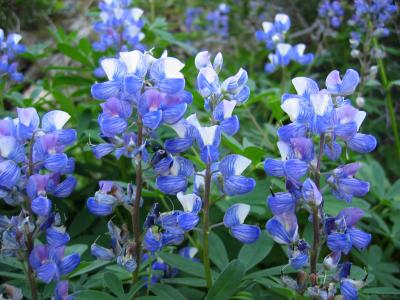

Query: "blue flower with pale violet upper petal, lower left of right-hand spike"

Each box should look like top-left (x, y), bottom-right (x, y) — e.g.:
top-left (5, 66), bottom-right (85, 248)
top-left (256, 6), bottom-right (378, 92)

top-left (266, 213), bottom-right (298, 245)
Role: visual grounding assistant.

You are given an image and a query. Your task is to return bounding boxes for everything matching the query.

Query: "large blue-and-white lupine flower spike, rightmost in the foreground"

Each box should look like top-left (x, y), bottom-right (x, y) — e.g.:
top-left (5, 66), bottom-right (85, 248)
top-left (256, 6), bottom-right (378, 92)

top-left (264, 69), bottom-right (376, 299)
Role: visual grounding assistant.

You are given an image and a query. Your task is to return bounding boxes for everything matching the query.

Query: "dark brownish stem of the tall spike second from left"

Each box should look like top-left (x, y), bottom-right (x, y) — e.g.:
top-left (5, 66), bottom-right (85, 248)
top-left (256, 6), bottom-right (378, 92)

top-left (132, 116), bottom-right (143, 284)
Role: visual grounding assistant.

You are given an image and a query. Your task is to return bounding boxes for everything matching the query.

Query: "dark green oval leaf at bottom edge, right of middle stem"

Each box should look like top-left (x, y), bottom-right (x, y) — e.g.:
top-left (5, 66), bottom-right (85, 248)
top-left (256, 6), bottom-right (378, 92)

top-left (205, 259), bottom-right (245, 300)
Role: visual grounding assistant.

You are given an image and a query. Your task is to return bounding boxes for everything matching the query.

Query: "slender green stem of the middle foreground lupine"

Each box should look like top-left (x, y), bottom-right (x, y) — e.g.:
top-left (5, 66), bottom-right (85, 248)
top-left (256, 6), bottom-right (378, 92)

top-left (203, 163), bottom-right (212, 289)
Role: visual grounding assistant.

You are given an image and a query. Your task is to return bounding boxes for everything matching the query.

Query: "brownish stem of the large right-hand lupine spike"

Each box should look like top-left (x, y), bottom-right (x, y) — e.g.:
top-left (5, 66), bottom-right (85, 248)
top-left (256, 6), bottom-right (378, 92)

top-left (310, 134), bottom-right (325, 285)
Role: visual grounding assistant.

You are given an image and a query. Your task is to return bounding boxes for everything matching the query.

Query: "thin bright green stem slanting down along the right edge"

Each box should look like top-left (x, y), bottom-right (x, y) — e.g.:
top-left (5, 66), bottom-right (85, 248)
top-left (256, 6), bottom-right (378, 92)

top-left (372, 37), bottom-right (400, 158)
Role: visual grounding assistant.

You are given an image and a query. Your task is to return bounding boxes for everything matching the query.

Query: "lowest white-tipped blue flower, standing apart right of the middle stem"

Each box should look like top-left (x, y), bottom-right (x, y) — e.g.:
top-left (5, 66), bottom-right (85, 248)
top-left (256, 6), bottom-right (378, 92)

top-left (224, 203), bottom-right (261, 244)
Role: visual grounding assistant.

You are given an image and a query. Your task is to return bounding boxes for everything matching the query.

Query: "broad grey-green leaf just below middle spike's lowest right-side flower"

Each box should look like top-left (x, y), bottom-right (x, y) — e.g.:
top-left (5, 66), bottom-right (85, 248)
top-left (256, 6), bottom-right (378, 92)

top-left (239, 231), bottom-right (274, 271)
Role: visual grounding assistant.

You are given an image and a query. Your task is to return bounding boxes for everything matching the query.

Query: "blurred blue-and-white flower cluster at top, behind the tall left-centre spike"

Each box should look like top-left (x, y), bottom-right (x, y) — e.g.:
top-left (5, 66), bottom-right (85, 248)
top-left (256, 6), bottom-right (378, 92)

top-left (93, 0), bottom-right (145, 52)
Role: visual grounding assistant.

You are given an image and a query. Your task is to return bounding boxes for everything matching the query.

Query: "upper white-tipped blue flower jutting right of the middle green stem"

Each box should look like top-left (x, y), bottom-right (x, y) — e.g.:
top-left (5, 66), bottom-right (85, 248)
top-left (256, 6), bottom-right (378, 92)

top-left (218, 154), bottom-right (256, 196)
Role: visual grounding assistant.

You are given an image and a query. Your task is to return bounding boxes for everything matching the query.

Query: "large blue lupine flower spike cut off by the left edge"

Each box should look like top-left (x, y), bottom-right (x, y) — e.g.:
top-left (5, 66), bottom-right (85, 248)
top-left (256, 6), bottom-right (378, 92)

top-left (0, 108), bottom-right (80, 299)
